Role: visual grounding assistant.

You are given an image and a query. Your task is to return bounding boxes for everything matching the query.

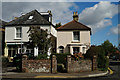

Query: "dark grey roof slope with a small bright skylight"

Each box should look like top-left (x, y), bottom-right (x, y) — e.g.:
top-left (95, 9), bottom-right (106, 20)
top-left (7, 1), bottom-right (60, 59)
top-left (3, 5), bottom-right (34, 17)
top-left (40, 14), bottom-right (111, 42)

top-left (7, 10), bottom-right (51, 26)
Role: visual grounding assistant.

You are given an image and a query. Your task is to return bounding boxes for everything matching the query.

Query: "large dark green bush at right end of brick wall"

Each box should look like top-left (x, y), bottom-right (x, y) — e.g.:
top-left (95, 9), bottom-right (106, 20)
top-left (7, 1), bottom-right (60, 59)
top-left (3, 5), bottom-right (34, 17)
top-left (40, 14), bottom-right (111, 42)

top-left (85, 46), bottom-right (109, 70)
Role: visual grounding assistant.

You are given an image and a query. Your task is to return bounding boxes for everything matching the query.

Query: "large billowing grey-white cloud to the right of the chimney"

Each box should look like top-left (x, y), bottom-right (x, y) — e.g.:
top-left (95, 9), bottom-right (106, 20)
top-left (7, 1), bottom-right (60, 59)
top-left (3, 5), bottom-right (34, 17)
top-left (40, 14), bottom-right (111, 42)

top-left (79, 1), bottom-right (118, 33)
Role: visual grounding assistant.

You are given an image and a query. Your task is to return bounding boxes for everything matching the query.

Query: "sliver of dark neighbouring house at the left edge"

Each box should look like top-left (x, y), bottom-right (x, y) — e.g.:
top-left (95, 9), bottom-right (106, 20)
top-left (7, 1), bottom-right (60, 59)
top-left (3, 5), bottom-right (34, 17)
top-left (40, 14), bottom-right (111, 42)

top-left (0, 20), bottom-right (7, 55)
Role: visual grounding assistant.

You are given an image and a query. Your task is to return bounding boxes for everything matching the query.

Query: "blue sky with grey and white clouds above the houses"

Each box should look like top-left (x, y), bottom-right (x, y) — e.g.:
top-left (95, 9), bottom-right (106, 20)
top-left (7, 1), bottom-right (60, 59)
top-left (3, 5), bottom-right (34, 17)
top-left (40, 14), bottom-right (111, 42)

top-left (2, 0), bottom-right (120, 46)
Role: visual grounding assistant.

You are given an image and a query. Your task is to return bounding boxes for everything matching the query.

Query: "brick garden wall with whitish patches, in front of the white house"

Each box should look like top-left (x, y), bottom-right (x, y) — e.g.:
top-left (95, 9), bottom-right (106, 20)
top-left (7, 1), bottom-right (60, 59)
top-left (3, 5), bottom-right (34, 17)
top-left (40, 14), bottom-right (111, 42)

top-left (22, 56), bottom-right (57, 73)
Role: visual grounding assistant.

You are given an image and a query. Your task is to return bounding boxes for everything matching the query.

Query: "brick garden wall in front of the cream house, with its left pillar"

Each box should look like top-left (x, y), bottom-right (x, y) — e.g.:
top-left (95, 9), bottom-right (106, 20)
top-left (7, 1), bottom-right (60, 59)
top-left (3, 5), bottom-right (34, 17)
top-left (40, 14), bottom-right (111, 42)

top-left (67, 56), bottom-right (92, 73)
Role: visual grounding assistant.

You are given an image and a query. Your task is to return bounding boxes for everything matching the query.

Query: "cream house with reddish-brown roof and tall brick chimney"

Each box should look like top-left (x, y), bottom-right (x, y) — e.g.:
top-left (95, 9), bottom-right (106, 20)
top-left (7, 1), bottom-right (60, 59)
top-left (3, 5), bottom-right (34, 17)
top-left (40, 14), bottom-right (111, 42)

top-left (57, 12), bottom-right (91, 54)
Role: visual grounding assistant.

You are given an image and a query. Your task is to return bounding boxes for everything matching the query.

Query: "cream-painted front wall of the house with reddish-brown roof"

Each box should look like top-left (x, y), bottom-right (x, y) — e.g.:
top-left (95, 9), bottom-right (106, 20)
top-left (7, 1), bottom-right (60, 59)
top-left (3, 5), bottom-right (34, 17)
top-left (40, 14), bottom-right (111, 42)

top-left (57, 31), bottom-right (90, 52)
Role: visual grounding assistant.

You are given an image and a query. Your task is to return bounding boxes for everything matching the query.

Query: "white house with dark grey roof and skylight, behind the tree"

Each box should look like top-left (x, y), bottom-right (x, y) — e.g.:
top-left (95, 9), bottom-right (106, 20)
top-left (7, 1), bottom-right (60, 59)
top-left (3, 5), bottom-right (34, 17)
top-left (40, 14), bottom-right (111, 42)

top-left (4, 10), bottom-right (57, 58)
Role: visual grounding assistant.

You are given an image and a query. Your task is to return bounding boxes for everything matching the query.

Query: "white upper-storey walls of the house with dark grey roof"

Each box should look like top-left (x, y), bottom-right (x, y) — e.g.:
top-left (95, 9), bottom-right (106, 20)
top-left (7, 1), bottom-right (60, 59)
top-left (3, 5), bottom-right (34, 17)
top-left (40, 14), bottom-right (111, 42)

top-left (5, 25), bottom-right (57, 42)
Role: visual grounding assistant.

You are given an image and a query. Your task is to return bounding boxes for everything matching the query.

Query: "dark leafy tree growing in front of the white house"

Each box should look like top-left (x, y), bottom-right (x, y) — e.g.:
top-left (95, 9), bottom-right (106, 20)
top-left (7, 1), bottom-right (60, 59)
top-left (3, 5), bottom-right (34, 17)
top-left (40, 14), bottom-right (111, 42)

top-left (28, 26), bottom-right (50, 54)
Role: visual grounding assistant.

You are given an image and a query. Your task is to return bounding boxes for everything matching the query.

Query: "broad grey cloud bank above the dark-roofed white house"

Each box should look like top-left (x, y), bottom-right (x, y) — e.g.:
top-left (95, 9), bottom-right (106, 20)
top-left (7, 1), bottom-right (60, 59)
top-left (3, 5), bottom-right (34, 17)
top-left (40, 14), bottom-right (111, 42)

top-left (2, 2), bottom-right (78, 24)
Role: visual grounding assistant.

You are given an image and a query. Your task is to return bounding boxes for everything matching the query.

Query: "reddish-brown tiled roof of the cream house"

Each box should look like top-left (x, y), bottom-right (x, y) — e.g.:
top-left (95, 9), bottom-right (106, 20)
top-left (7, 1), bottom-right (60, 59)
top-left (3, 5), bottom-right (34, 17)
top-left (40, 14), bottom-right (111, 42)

top-left (57, 20), bottom-right (91, 30)
